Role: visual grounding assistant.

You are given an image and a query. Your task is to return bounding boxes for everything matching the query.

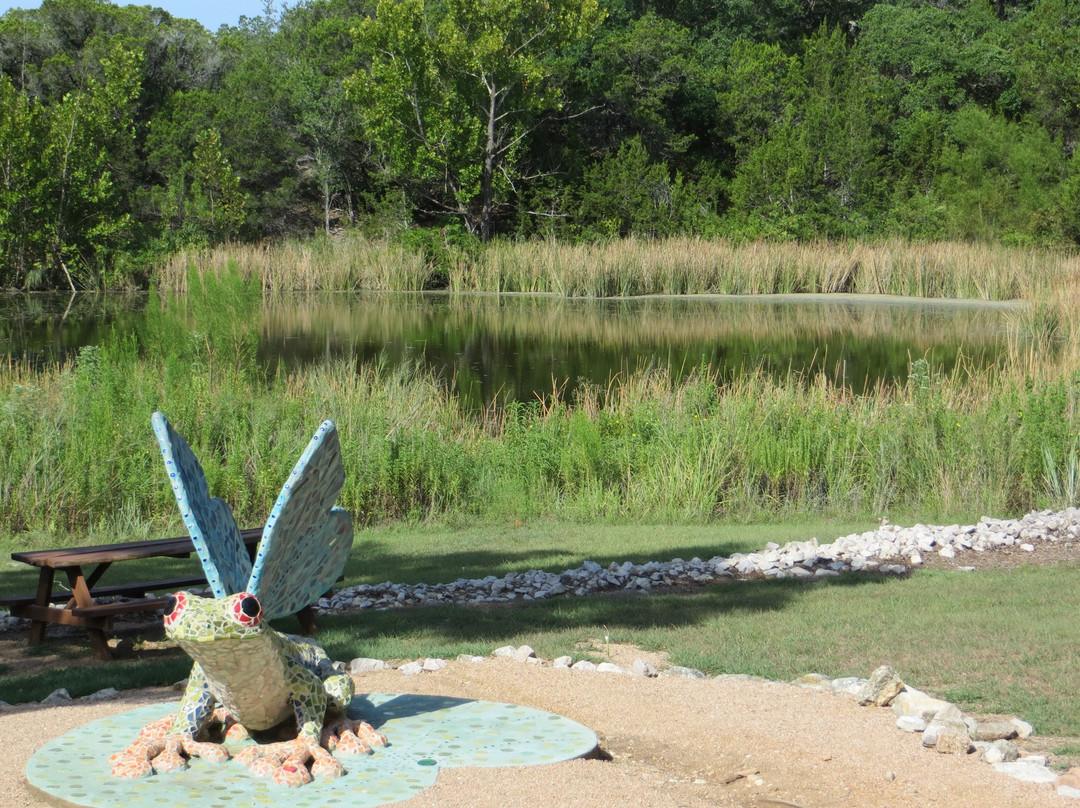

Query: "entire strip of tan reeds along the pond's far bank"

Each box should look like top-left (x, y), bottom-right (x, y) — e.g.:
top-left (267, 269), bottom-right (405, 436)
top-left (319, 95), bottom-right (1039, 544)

top-left (156, 237), bottom-right (1080, 300)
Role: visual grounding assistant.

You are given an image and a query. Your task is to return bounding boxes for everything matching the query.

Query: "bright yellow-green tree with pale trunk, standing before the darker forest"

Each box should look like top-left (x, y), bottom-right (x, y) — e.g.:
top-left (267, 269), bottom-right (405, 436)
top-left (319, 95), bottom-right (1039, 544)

top-left (346, 0), bottom-right (602, 240)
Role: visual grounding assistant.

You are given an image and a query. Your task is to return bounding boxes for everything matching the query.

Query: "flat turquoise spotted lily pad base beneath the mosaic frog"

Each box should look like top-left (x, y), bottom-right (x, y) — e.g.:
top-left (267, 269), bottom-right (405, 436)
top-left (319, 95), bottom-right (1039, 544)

top-left (26, 693), bottom-right (596, 808)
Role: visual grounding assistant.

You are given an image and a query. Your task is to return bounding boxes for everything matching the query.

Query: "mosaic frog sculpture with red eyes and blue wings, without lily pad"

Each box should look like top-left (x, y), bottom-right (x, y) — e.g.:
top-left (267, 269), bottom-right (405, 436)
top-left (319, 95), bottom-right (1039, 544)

top-left (110, 413), bottom-right (387, 785)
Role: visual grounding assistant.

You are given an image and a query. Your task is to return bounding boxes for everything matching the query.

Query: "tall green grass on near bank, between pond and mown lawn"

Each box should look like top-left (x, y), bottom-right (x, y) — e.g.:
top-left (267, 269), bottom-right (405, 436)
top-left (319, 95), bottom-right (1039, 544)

top-left (0, 301), bottom-right (1080, 543)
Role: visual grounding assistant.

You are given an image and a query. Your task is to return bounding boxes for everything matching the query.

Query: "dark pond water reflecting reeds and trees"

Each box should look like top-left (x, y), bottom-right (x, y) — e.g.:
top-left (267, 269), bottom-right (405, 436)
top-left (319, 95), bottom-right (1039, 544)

top-left (0, 293), bottom-right (1015, 407)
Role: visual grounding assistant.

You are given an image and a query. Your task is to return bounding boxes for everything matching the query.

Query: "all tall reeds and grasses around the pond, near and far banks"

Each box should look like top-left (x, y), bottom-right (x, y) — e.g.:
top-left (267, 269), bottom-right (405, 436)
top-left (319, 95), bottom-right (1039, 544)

top-left (8, 240), bottom-right (1080, 543)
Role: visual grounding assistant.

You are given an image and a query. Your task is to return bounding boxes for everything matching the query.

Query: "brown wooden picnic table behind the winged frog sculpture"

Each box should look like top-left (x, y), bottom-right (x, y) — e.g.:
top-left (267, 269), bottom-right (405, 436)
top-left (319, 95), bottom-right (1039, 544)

top-left (0, 527), bottom-right (315, 659)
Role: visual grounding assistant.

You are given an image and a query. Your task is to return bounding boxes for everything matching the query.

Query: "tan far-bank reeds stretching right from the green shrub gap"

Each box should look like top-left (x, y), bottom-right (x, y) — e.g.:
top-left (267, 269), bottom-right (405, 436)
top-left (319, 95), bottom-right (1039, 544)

top-left (468, 238), bottom-right (1067, 300)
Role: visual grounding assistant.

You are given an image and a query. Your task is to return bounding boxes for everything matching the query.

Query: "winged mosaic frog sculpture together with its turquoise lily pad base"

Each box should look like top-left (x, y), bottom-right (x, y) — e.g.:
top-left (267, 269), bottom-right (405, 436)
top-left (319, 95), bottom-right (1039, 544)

top-left (39, 413), bottom-right (596, 808)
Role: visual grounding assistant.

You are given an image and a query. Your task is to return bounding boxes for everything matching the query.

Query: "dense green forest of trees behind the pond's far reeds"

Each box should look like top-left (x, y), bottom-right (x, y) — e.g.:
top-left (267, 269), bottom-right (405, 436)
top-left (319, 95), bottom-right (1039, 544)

top-left (0, 0), bottom-right (1080, 288)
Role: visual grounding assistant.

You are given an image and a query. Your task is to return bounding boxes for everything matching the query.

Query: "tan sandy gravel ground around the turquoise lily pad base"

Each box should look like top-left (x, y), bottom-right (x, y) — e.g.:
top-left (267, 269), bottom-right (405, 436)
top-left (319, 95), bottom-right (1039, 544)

top-left (0, 649), bottom-right (1080, 808)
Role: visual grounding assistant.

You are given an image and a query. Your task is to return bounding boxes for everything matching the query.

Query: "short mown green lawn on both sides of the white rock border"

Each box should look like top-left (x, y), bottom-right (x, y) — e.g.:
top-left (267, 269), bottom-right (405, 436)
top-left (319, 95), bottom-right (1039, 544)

top-left (0, 522), bottom-right (1080, 736)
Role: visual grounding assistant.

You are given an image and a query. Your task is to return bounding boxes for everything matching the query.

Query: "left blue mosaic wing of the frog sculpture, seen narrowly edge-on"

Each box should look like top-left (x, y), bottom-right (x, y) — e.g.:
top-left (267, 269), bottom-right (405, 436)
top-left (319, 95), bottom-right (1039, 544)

top-left (151, 413), bottom-right (252, 597)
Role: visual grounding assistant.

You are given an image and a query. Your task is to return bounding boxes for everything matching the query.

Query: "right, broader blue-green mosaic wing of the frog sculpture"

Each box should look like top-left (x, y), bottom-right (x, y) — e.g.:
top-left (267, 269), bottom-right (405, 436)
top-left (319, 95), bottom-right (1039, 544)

top-left (246, 420), bottom-right (352, 619)
